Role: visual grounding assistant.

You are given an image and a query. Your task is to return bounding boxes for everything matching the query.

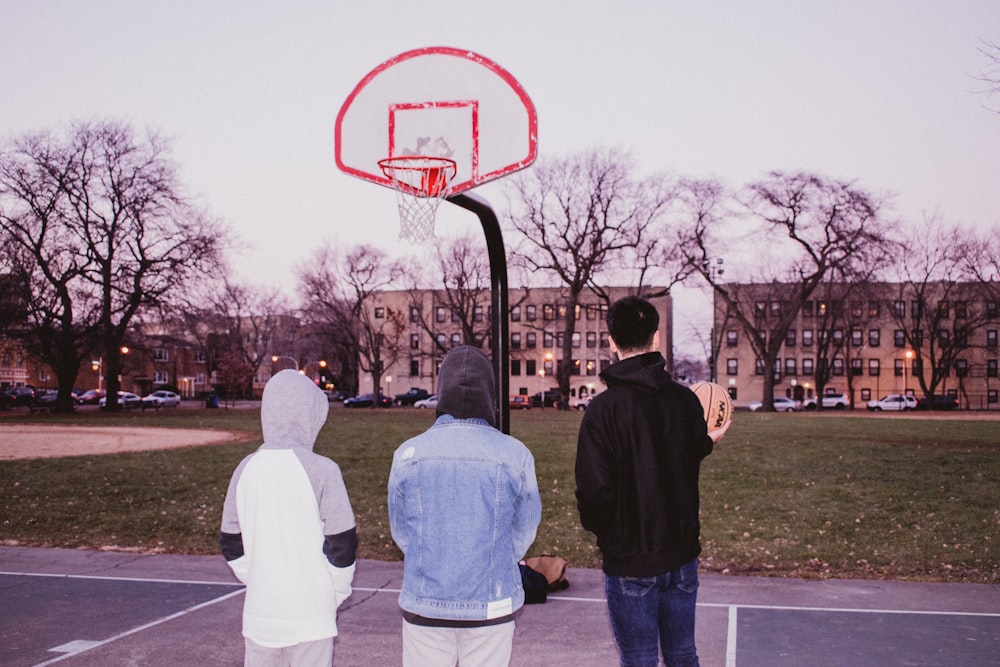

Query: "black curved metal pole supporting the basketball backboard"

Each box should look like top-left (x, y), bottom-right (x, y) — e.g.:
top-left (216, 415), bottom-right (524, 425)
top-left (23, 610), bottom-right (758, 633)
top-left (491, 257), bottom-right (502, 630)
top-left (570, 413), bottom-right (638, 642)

top-left (448, 193), bottom-right (510, 434)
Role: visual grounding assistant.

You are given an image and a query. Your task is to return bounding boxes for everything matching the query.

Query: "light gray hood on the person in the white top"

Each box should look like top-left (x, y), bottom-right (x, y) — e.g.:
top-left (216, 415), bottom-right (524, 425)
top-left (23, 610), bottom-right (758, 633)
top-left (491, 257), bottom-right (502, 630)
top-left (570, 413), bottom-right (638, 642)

top-left (260, 369), bottom-right (330, 451)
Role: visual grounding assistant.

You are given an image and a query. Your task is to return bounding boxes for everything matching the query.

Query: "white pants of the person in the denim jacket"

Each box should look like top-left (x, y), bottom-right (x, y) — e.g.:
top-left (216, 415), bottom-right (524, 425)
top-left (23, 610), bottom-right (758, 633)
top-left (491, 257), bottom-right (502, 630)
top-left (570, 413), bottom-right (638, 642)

top-left (403, 621), bottom-right (514, 667)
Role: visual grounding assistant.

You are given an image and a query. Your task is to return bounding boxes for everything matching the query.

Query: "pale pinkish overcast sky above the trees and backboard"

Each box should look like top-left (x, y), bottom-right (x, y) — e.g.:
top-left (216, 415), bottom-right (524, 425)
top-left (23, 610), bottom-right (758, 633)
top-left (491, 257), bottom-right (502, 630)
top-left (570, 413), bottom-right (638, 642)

top-left (0, 0), bottom-right (1000, 354)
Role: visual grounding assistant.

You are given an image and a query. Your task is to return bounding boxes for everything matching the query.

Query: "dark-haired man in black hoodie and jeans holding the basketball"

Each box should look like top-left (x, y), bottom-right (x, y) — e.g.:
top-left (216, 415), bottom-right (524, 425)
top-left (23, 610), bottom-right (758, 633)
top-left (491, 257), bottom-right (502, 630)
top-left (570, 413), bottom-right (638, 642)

top-left (576, 297), bottom-right (728, 667)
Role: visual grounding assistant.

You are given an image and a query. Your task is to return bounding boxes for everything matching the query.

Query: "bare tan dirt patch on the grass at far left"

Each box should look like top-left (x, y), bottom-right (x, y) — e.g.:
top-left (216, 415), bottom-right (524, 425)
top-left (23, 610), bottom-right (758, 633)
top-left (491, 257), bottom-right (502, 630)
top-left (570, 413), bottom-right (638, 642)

top-left (0, 424), bottom-right (259, 461)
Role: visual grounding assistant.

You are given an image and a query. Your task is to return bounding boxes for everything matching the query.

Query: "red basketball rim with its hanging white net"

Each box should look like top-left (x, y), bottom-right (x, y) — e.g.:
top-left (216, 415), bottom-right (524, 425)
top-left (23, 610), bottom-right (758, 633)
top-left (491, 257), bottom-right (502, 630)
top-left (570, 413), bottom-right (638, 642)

top-left (378, 155), bottom-right (458, 244)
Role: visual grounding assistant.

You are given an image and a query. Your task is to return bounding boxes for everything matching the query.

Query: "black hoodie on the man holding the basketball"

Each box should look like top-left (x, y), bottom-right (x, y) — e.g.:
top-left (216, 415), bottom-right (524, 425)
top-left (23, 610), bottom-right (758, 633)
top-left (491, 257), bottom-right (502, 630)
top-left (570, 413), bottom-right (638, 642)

top-left (576, 352), bottom-right (712, 577)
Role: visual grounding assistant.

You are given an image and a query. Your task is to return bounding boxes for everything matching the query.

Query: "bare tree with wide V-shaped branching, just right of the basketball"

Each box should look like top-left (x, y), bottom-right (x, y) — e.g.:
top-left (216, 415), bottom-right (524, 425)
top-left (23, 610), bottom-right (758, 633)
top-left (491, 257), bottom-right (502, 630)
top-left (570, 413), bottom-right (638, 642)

top-left (683, 172), bottom-right (890, 410)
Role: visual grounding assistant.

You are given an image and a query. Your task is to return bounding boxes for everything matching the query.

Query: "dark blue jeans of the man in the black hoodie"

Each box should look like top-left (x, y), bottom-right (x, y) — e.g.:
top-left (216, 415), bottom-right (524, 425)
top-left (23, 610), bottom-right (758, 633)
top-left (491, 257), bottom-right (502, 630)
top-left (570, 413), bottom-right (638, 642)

top-left (604, 558), bottom-right (698, 667)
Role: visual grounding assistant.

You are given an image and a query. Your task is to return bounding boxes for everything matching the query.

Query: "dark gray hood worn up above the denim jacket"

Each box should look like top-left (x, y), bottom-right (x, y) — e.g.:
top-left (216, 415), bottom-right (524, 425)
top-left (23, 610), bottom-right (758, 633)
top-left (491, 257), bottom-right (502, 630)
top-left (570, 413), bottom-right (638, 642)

top-left (437, 345), bottom-right (496, 426)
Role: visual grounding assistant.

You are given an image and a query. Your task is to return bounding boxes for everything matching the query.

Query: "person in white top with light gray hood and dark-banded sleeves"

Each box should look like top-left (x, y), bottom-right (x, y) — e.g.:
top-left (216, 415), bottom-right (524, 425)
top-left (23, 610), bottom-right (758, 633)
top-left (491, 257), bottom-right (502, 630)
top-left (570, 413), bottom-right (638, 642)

top-left (219, 370), bottom-right (358, 666)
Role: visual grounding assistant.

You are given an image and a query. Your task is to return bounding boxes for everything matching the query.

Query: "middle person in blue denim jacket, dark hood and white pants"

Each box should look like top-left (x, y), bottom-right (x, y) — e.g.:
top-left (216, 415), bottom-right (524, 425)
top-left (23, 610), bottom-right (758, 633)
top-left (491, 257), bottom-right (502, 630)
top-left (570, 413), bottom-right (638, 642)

top-left (388, 346), bottom-right (541, 667)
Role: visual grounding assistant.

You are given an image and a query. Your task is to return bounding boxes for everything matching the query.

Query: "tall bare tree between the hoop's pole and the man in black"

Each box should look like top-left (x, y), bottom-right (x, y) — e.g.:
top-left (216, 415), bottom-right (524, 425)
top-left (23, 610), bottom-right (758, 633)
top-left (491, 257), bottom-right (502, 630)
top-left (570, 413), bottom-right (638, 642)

top-left (508, 149), bottom-right (674, 409)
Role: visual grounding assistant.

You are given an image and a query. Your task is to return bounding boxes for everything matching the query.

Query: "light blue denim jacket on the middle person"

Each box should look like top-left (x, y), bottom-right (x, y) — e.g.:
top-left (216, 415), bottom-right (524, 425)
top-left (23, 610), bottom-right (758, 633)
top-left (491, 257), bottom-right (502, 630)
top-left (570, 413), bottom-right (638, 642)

top-left (388, 414), bottom-right (542, 621)
